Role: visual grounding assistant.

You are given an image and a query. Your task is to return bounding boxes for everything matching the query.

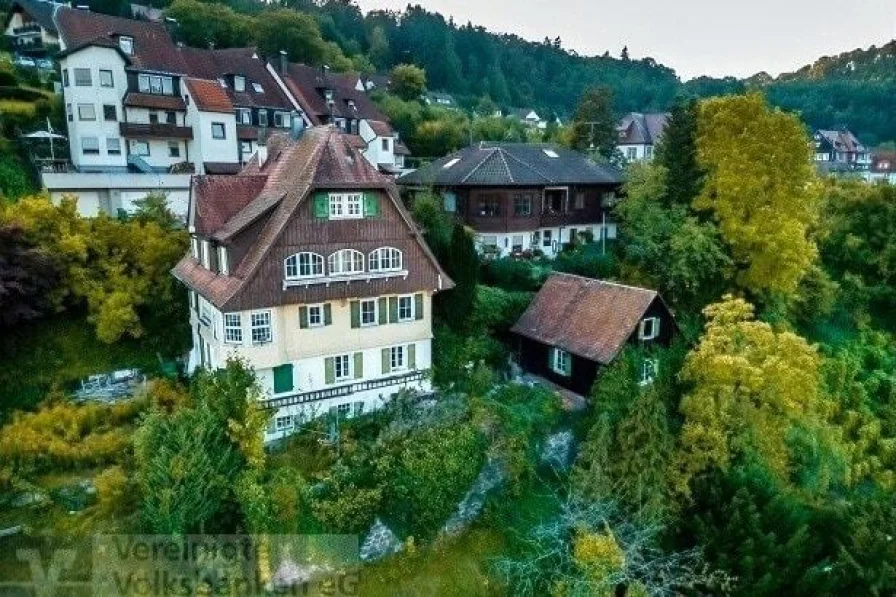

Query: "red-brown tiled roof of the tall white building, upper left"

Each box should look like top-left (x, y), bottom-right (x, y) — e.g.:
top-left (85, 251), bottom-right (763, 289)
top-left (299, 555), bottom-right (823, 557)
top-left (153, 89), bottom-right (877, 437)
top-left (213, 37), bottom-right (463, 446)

top-left (56, 7), bottom-right (187, 74)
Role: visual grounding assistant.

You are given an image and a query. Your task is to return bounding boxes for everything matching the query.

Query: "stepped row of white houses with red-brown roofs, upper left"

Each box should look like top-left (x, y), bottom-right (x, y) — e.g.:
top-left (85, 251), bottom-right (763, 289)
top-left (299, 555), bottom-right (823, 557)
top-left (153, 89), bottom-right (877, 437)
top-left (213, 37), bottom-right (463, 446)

top-left (27, 0), bottom-right (407, 217)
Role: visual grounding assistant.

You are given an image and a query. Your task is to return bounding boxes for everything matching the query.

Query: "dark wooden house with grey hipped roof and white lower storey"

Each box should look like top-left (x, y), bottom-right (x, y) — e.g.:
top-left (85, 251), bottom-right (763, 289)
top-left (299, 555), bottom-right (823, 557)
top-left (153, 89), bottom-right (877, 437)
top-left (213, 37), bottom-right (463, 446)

top-left (398, 142), bottom-right (622, 257)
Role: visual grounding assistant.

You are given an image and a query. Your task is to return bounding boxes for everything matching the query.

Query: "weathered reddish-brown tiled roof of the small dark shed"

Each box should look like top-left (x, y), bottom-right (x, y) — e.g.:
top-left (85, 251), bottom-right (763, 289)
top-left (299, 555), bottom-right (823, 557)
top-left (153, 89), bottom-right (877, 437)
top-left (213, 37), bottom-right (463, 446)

top-left (511, 274), bottom-right (658, 365)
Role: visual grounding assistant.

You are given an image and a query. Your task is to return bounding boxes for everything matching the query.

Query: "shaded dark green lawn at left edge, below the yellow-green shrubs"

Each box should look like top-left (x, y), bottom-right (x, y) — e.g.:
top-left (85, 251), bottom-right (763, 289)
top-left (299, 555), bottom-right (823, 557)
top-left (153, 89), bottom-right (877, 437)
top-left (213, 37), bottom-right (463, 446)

top-left (0, 314), bottom-right (172, 423)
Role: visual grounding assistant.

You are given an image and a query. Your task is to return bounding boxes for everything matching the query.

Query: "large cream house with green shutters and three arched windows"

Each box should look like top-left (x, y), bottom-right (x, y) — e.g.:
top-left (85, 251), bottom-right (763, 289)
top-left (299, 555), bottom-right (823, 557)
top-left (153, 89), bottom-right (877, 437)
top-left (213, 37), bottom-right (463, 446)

top-left (174, 126), bottom-right (453, 441)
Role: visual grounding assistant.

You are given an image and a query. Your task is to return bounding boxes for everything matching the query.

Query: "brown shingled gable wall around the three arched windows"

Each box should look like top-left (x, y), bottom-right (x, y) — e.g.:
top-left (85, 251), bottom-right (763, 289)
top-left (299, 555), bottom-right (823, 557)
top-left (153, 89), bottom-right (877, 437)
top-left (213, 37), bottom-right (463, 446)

top-left (227, 190), bottom-right (439, 310)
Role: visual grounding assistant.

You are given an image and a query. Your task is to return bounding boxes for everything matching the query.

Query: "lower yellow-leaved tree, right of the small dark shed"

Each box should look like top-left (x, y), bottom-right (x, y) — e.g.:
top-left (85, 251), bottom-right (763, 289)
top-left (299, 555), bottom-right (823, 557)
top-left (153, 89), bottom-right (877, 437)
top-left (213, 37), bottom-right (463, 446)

top-left (673, 295), bottom-right (824, 495)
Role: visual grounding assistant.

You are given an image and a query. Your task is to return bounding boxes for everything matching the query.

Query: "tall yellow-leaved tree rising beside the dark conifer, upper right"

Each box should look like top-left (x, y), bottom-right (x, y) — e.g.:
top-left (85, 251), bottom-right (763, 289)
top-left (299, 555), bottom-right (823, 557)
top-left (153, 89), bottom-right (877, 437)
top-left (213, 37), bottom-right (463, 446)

top-left (694, 93), bottom-right (819, 295)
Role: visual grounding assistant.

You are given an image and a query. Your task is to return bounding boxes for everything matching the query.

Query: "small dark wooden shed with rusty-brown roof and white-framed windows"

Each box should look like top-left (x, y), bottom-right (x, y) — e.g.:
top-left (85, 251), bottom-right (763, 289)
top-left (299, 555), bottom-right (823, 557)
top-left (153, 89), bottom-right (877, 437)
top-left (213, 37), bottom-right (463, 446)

top-left (511, 274), bottom-right (678, 396)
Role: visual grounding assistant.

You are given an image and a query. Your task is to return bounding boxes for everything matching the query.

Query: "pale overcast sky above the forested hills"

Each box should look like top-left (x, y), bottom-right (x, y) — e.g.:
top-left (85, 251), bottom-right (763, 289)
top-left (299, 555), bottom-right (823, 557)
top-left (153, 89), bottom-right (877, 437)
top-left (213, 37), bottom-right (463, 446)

top-left (358, 0), bottom-right (896, 79)
